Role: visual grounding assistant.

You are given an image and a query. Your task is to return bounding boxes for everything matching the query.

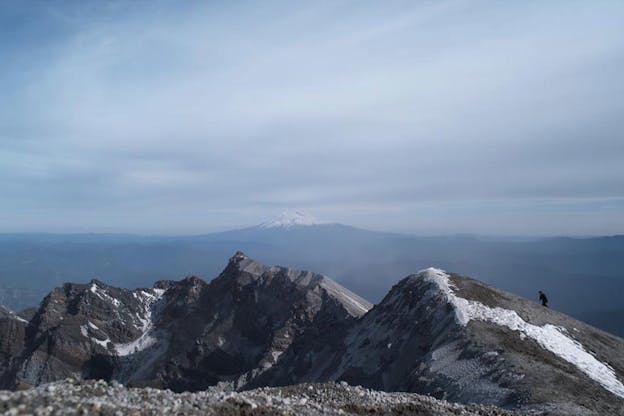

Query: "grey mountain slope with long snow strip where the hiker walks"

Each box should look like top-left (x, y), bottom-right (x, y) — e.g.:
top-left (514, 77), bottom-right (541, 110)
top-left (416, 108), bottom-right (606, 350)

top-left (330, 269), bottom-right (624, 414)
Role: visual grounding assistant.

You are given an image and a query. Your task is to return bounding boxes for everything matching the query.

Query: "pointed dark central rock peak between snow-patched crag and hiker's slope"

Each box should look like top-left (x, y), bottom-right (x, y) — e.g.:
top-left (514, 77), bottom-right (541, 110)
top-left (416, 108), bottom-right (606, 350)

top-left (144, 253), bottom-right (371, 391)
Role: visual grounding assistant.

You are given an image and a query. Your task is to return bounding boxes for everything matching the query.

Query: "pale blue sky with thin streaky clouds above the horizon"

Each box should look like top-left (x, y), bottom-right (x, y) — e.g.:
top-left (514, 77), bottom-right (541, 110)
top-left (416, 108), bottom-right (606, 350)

top-left (0, 0), bottom-right (624, 235)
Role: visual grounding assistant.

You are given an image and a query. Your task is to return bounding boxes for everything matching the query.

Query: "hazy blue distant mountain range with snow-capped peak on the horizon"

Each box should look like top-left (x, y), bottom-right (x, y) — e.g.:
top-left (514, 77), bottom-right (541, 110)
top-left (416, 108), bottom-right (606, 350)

top-left (0, 213), bottom-right (624, 336)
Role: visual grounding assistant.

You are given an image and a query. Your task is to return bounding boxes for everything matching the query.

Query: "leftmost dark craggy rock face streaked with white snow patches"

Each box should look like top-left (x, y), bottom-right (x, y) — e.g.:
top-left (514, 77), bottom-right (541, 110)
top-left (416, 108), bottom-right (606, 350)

top-left (10, 280), bottom-right (166, 386)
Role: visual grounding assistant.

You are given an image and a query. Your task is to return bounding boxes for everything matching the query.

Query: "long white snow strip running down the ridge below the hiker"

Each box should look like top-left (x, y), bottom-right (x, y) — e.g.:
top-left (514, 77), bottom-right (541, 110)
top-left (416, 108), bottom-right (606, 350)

top-left (418, 268), bottom-right (624, 398)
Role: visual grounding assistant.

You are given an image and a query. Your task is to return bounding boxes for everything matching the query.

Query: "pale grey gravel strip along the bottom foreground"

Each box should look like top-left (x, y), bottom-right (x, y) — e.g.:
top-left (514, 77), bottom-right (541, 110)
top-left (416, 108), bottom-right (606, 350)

top-left (0, 379), bottom-right (532, 416)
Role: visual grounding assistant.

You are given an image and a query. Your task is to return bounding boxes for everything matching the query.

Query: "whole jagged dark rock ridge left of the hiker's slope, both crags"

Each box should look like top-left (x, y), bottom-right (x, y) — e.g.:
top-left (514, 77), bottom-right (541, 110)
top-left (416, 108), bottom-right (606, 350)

top-left (5, 253), bottom-right (371, 391)
